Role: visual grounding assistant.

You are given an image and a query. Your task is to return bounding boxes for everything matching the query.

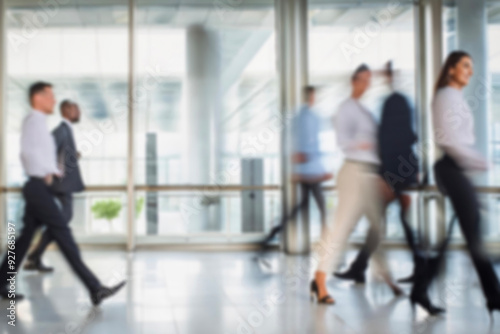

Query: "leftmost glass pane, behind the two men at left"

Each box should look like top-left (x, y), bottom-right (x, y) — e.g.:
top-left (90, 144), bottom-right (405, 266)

top-left (4, 0), bottom-right (128, 240)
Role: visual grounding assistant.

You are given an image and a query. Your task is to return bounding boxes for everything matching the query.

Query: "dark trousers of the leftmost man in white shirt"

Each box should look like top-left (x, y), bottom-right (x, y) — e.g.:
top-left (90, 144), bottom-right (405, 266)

top-left (0, 178), bottom-right (101, 293)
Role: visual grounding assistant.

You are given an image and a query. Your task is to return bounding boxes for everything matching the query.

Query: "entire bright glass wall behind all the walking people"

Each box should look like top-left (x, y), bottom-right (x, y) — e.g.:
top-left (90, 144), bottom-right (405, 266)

top-left (2, 0), bottom-right (500, 248)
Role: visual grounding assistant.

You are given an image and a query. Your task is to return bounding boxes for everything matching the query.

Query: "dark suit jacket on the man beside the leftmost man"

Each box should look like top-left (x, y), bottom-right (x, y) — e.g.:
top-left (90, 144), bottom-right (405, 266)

top-left (52, 122), bottom-right (85, 193)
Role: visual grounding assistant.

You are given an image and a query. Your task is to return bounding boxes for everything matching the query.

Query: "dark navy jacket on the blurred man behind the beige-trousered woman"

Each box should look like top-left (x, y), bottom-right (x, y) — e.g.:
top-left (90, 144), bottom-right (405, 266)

top-left (378, 92), bottom-right (418, 192)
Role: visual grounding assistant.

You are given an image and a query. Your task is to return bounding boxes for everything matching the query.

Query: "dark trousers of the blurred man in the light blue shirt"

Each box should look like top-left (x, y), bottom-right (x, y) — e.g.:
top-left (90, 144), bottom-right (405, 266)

top-left (263, 182), bottom-right (326, 244)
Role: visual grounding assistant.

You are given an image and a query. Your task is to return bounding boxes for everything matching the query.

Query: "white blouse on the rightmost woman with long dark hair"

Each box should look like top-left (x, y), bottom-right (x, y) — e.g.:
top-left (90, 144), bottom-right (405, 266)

top-left (432, 86), bottom-right (487, 170)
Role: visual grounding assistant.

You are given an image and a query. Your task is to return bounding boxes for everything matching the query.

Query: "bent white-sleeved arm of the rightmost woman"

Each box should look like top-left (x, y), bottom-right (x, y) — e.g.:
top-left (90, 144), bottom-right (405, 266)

top-left (433, 90), bottom-right (487, 170)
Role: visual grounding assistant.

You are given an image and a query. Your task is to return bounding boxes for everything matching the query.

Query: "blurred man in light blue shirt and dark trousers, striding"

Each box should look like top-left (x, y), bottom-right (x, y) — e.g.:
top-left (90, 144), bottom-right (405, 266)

top-left (263, 86), bottom-right (332, 246)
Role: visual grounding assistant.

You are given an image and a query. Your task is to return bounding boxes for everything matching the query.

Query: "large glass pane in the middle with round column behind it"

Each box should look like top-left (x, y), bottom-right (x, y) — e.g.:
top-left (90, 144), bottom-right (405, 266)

top-left (134, 0), bottom-right (280, 236)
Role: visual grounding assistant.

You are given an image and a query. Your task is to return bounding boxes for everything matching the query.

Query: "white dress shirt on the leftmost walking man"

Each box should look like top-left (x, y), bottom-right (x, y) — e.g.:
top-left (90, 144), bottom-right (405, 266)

top-left (21, 110), bottom-right (60, 178)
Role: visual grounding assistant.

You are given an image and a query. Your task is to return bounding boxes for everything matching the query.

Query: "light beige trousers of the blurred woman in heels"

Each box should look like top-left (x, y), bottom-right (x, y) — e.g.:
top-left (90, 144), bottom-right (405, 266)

top-left (317, 161), bottom-right (390, 278)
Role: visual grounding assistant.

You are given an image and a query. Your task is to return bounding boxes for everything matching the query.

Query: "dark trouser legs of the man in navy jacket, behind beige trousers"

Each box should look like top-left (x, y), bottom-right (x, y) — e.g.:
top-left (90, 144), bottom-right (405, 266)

top-left (349, 197), bottom-right (416, 273)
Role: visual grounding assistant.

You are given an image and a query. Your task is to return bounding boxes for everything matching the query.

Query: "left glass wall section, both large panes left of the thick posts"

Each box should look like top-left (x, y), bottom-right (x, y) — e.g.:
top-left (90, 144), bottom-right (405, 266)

top-left (4, 0), bottom-right (280, 241)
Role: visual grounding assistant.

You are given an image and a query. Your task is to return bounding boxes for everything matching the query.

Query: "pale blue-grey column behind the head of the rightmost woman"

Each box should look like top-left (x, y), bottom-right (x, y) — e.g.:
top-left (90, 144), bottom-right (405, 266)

top-left (455, 0), bottom-right (490, 185)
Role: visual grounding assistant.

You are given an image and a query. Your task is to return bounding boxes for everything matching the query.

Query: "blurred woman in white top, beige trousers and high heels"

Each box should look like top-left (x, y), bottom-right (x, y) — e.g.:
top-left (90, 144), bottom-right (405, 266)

top-left (311, 65), bottom-right (402, 304)
